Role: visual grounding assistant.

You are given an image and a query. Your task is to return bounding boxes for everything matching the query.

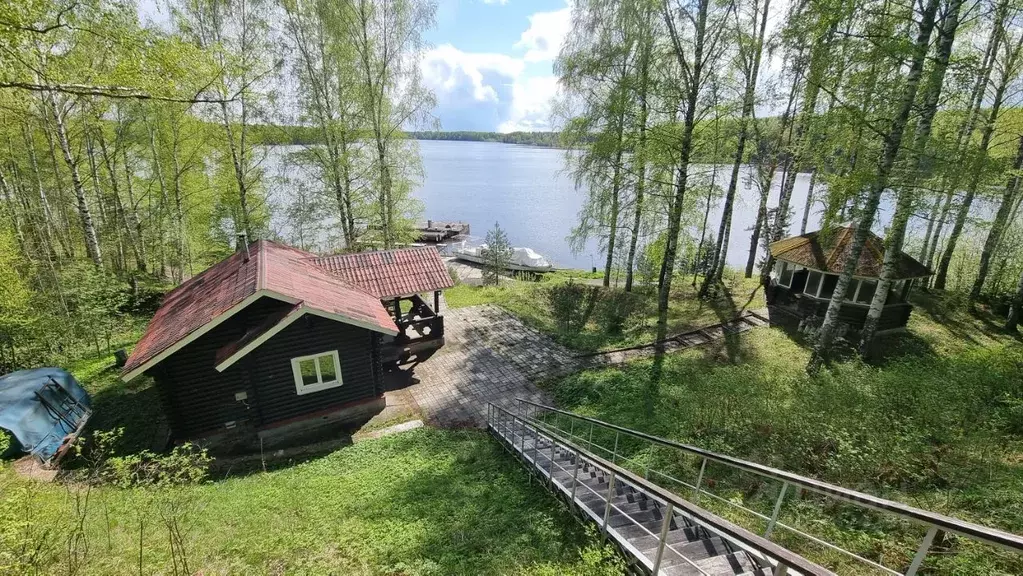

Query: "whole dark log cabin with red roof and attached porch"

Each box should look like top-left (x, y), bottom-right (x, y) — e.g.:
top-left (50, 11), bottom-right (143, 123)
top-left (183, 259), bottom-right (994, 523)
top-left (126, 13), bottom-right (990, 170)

top-left (122, 238), bottom-right (452, 442)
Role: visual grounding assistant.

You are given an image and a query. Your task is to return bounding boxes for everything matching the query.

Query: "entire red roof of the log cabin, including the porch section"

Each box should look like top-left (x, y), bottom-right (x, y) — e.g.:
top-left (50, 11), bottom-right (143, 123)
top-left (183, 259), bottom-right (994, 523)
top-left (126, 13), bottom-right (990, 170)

top-left (122, 240), bottom-right (452, 381)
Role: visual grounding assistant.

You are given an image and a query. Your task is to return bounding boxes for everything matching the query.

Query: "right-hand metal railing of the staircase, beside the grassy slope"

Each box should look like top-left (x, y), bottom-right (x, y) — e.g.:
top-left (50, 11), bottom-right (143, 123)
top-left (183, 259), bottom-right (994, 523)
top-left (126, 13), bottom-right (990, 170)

top-left (517, 398), bottom-right (1023, 576)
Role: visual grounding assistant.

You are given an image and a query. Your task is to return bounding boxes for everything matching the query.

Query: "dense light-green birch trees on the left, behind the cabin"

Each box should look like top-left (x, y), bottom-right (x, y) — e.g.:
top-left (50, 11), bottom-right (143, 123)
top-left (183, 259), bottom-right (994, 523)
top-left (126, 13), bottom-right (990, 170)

top-left (0, 0), bottom-right (435, 365)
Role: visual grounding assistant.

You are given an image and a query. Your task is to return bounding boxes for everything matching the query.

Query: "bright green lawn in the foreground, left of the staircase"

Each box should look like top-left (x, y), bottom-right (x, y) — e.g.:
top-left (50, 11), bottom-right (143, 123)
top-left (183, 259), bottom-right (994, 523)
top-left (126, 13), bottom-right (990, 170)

top-left (0, 429), bottom-right (621, 575)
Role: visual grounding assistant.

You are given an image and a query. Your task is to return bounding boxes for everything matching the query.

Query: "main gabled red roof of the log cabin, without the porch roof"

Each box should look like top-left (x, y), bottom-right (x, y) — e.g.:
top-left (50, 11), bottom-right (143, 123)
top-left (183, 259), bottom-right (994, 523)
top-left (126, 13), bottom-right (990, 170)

top-left (122, 240), bottom-right (401, 378)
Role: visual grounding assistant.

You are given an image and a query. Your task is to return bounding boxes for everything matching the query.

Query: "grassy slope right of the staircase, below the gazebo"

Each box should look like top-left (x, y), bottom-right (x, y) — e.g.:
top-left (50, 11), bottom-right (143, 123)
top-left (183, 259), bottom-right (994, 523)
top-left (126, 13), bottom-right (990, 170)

top-left (545, 295), bottom-right (1023, 574)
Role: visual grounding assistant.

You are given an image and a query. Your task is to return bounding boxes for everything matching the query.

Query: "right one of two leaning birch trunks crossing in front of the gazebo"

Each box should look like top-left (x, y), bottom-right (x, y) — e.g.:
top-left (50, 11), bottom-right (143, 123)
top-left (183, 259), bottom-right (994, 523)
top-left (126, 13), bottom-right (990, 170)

top-left (859, 0), bottom-right (964, 351)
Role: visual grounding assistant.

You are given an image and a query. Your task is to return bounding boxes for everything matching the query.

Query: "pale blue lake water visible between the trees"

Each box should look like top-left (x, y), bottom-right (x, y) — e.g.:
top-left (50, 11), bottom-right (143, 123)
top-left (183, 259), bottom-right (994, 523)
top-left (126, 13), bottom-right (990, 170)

top-left (266, 140), bottom-right (953, 268)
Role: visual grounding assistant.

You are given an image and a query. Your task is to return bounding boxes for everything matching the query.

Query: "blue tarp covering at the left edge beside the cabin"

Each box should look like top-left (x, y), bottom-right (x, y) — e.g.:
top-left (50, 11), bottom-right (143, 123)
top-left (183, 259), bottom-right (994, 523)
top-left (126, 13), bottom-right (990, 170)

top-left (0, 368), bottom-right (92, 462)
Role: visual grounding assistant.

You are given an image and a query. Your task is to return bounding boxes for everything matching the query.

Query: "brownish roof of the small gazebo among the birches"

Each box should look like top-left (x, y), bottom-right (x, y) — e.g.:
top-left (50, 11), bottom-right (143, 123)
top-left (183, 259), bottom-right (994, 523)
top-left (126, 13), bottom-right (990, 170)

top-left (770, 224), bottom-right (934, 279)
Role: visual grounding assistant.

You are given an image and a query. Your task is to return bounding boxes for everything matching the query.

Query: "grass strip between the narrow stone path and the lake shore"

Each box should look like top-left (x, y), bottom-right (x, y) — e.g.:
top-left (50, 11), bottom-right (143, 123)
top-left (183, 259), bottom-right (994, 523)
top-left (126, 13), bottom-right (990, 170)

top-left (444, 271), bottom-right (765, 352)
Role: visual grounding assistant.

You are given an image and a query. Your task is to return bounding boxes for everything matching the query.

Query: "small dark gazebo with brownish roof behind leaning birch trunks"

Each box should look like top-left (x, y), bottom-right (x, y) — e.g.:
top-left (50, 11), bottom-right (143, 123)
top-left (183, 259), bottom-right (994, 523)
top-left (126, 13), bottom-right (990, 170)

top-left (767, 224), bottom-right (933, 333)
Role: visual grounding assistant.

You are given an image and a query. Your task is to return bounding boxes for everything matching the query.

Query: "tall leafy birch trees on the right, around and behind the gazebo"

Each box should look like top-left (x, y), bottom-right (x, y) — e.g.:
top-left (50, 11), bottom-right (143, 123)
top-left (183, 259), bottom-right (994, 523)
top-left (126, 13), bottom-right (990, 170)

top-left (555, 0), bottom-right (1023, 370)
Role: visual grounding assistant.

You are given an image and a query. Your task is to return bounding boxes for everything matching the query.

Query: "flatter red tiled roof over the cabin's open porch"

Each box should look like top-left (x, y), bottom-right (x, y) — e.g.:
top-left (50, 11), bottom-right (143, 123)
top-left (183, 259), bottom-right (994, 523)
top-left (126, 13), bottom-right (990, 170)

top-left (313, 246), bottom-right (454, 299)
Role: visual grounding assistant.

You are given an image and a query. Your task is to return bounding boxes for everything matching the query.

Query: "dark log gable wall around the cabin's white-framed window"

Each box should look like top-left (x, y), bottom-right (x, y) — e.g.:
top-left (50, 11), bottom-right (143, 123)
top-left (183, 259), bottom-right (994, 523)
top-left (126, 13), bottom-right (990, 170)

top-left (149, 298), bottom-right (382, 440)
